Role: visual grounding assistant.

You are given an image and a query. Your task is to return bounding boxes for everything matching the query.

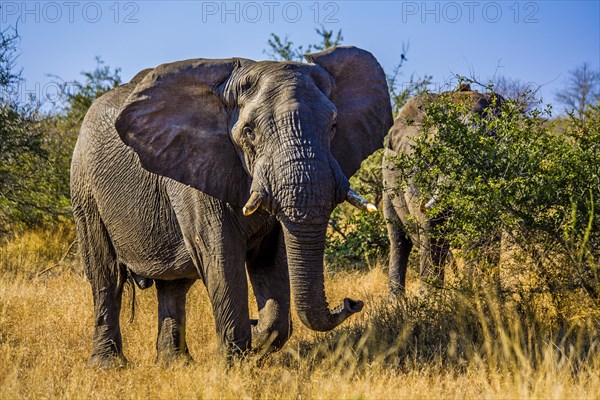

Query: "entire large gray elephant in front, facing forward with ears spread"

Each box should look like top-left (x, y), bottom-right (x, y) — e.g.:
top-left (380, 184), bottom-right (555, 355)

top-left (71, 47), bottom-right (392, 367)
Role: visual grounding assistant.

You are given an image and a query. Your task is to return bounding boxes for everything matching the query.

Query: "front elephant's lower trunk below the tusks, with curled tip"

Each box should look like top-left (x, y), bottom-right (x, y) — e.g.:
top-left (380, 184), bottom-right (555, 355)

top-left (283, 223), bottom-right (363, 332)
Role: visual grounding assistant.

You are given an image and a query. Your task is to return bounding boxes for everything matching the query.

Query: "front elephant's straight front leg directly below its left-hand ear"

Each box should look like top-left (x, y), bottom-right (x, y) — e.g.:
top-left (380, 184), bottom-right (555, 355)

top-left (169, 189), bottom-right (251, 360)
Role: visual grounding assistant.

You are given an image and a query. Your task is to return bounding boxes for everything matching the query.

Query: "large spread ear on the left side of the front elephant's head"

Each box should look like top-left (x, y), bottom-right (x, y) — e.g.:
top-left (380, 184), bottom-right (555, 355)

top-left (115, 59), bottom-right (252, 205)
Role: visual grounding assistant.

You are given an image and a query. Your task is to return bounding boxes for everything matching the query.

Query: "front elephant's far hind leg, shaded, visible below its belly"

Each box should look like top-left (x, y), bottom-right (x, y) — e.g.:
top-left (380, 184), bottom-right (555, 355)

top-left (156, 279), bottom-right (194, 364)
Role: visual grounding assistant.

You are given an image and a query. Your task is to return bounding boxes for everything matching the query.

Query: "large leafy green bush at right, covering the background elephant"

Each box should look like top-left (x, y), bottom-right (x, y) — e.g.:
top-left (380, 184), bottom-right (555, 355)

top-left (395, 83), bottom-right (600, 305)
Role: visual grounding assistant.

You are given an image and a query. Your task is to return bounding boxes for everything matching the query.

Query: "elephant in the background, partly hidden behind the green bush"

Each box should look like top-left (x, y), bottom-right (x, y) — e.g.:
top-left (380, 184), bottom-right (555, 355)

top-left (383, 85), bottom-right (493, 296)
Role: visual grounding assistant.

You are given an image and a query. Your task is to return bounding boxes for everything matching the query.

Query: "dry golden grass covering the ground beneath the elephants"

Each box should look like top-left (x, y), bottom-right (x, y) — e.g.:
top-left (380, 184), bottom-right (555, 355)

top-left (0, 230), bottom-right (600, 399)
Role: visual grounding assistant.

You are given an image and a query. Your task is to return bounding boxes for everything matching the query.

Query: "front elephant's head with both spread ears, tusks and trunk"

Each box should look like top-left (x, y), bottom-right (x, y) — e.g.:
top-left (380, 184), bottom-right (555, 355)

top-left (116, 47), bottom-right (392, 331)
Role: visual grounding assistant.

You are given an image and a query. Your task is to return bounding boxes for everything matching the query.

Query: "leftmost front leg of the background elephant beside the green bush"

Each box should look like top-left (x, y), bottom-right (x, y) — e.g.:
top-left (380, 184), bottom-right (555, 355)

top-left (383, 192), bottom-right (413, 296)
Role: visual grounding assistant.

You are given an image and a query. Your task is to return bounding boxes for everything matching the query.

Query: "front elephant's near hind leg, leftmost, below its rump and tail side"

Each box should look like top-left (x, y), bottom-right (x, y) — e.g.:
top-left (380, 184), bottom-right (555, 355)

top-left (73, 202), bottom-right (127, 369)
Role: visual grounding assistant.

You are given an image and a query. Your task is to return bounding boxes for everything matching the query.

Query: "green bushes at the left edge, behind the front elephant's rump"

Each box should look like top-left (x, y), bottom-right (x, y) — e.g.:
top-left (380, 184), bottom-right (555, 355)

top-left (0, 31), bottom-right (120, 238)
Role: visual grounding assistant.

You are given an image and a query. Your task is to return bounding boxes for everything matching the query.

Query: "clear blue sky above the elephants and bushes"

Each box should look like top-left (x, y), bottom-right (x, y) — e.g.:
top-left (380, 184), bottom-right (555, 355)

top-left (0, 0), bottom-right (600, 110)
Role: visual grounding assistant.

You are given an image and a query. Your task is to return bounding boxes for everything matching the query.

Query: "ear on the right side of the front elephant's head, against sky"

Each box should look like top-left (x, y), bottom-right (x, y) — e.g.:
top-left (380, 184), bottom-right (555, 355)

top-left (305, 47), bottom-right (393, 177)
